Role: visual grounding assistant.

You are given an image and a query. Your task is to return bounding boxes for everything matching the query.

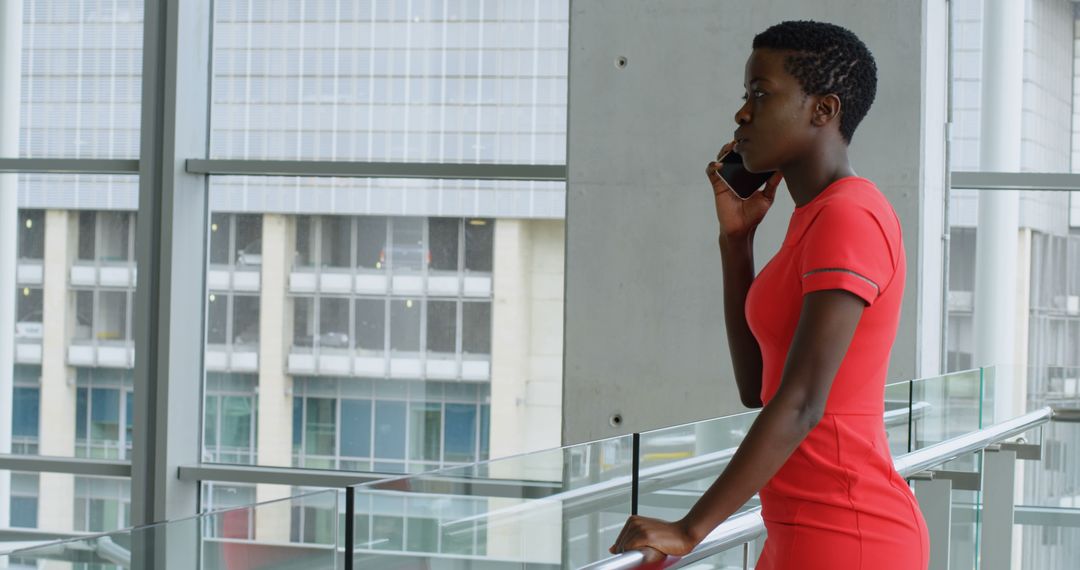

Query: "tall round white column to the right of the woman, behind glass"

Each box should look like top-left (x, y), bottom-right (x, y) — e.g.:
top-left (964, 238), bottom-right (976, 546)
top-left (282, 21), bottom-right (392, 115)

top-left (974, 0), bottom-right (1026, 421)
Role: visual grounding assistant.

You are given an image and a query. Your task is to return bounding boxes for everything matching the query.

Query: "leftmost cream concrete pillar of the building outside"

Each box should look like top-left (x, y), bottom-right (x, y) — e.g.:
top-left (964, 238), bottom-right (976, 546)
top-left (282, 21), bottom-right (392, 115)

top-left (38, 209), bottom-right (79, 531)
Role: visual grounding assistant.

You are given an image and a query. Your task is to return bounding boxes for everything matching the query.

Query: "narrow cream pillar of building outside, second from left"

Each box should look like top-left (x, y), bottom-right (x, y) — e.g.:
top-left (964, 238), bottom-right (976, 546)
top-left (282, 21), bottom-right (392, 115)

top-left (255, 214), bottom-right (296, 541)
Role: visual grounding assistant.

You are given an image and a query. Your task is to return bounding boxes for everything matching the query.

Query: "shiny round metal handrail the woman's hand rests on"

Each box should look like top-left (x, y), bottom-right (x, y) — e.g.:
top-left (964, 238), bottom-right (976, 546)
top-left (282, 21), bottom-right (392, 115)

top-left (581, 407), bottom-right (1054, 570)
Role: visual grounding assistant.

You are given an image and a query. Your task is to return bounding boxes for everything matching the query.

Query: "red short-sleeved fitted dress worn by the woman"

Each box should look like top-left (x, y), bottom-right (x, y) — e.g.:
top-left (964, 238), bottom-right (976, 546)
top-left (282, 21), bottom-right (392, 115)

top-left (746, 176), bottom-right (930, 570)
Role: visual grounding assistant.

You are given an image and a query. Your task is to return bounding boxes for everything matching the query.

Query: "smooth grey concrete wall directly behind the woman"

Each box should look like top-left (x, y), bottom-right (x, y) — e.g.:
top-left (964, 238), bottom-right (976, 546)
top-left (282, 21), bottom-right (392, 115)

top-left (563, 0), bottom-right (944, 443)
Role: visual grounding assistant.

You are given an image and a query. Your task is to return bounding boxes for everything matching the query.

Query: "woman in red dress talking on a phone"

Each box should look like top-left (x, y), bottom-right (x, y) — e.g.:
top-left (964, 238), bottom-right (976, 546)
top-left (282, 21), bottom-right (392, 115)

top-left (611, 22), bottom-right (929, 570)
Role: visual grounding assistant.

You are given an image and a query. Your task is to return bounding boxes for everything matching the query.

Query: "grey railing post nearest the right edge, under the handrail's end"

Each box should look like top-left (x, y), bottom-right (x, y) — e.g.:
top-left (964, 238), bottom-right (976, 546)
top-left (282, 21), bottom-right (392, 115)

top-left (978, 447), bottom-right (1016, 570)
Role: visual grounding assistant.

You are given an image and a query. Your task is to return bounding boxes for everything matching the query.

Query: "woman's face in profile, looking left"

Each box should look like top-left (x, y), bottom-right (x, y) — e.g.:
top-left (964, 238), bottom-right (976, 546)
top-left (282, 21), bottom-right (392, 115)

top-left (734, 49), bottom-right (814, 172)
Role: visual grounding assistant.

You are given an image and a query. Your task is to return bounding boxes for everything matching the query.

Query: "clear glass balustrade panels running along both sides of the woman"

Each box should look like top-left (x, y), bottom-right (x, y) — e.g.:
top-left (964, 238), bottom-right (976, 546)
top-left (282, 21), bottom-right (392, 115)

top-left (6, 369), bottom-right (1080, 570)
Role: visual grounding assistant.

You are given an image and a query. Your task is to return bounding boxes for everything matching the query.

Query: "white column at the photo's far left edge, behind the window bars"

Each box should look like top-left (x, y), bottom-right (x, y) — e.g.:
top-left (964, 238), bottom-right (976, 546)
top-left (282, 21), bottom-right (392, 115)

top-left (0, 2), bottom-right (23, 527)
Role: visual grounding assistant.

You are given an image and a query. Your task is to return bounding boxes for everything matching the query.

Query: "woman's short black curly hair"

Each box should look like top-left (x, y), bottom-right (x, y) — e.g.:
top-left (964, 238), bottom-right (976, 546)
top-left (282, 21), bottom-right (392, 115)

top-left (754, 21), bottom-right (877, 145)
